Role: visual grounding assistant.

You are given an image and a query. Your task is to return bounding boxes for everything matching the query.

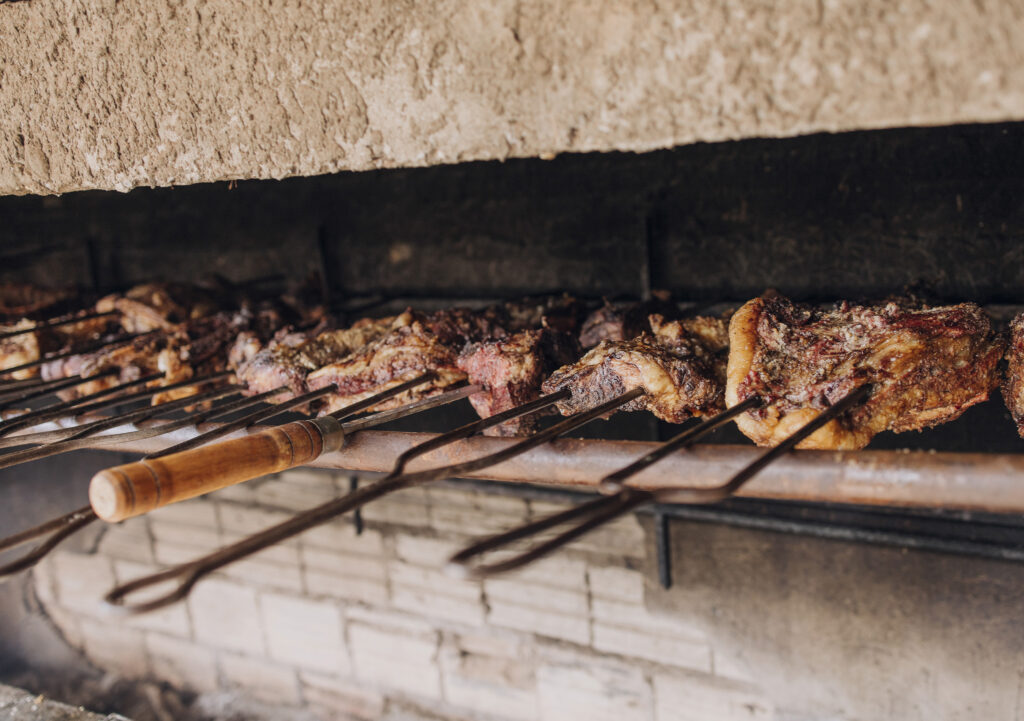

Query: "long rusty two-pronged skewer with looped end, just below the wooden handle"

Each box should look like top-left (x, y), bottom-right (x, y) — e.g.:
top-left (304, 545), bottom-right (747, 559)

top-left (104, 388), bottom-right (643, 613)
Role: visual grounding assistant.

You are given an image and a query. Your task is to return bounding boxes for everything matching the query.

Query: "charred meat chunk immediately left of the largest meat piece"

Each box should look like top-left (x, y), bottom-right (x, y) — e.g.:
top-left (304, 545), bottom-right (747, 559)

top-left (543, 319), bottom-right (725, 423)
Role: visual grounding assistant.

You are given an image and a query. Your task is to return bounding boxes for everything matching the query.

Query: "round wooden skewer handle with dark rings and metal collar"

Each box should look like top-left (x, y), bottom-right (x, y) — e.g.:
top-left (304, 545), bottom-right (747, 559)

top-left (89, 416), bottom-right (345, 522)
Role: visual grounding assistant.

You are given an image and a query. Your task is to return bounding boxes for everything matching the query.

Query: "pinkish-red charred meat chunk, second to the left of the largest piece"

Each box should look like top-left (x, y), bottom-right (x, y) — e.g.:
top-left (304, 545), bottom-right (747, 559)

top-left (457, 329), bottom-right (580, 436)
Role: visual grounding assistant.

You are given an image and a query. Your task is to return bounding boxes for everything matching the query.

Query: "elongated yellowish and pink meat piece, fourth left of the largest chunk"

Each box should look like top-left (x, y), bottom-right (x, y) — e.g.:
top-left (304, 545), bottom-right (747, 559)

top-left (236, 317), bottom-right (395, 395)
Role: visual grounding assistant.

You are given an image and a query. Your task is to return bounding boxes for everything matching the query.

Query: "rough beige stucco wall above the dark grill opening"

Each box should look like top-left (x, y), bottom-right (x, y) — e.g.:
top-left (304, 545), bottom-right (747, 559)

top-left (0, 0), bottom-right (1024, 194)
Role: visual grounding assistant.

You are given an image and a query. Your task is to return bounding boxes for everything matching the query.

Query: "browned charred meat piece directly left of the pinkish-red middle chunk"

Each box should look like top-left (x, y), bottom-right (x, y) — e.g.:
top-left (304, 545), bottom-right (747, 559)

top-left (306, 311), bottom-right (466, 413)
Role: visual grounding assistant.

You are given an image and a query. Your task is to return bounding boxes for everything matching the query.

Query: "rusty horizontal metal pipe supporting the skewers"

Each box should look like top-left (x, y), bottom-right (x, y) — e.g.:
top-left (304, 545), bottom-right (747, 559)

top-left (75, 421), bottom-right (1024, 513)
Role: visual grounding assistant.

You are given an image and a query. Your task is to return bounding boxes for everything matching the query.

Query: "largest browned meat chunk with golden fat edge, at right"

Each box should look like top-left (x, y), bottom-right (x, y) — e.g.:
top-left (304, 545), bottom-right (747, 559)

top-left (726, 296), bottom-right (1005, 450)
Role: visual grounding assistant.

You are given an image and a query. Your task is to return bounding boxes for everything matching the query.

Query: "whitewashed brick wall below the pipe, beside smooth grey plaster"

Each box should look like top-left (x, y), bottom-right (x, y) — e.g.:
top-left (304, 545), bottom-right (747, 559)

top-left (34, 471), bottom-right (773, 721)
